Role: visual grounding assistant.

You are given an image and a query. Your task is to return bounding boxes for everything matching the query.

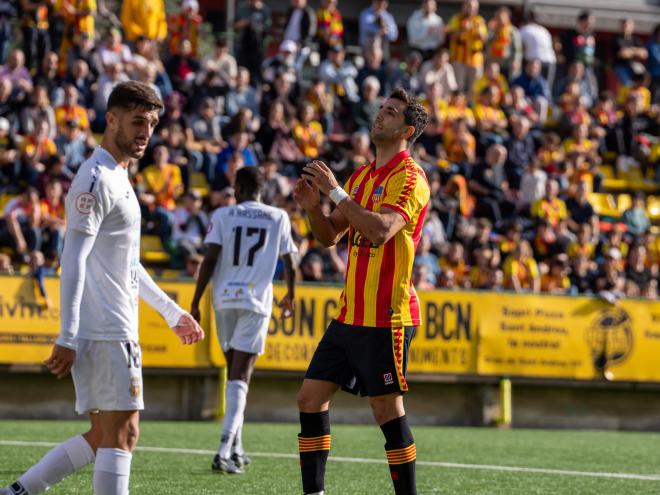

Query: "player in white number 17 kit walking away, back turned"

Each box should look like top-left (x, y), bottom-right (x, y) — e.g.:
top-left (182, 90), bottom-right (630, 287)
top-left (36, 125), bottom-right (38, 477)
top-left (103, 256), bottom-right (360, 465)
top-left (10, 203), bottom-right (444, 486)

top-left (190, 167), bottom-right (297, 474)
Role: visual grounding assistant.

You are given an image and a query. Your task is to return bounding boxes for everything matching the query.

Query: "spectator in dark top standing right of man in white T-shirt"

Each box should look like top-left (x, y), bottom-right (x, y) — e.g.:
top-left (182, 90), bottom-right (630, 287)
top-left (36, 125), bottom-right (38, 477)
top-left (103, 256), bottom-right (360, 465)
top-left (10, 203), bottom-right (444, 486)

top-left (562, 10), bottom-right (598, 101)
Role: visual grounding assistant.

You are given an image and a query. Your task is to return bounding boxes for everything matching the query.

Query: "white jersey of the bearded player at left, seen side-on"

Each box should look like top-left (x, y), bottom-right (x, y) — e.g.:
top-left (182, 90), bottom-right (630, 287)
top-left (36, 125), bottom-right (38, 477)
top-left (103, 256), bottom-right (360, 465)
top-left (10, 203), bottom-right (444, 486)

top-left (63, 147), bottom-right (140, 341)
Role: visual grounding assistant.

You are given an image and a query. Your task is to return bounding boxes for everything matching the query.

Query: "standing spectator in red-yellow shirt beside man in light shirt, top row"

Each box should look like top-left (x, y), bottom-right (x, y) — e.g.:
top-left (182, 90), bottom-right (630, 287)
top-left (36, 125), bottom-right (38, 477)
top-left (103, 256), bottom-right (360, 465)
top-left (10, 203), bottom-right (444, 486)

top-left (446, 0), bottom-right (488, 99)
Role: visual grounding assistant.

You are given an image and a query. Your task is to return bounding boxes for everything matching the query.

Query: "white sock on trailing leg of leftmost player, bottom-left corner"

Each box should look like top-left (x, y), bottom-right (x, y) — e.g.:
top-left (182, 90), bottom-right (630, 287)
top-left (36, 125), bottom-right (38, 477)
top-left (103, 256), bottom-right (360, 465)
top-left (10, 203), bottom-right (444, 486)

top-left (18, 435), bottom-right (94, 495)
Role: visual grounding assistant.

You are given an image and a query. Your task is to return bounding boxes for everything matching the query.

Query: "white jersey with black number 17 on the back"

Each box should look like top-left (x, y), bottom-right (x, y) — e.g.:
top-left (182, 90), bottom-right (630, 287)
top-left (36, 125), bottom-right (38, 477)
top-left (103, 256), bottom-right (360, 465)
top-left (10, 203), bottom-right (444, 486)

top-left (205, 201), bottom-right (297, 316)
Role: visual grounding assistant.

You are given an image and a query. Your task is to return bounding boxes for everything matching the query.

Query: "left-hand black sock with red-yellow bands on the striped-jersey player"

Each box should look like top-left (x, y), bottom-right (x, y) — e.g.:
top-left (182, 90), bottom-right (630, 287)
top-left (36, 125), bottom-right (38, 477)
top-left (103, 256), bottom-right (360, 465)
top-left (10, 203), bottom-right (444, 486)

top-left (298, 411), bottom-right (331, 493)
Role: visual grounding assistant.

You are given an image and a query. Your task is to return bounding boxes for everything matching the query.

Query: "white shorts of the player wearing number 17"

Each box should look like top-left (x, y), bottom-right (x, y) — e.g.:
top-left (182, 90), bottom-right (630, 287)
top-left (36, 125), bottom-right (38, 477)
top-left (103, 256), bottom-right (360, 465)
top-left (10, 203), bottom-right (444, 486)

top-left (215, 308), bottom-right (270, 355)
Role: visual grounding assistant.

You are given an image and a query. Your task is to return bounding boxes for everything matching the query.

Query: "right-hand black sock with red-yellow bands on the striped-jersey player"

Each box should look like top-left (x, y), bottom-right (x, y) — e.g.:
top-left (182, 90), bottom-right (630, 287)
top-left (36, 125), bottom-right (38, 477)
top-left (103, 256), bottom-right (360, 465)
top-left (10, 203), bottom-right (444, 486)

top-left (380, 416), bottom-right (417, 495)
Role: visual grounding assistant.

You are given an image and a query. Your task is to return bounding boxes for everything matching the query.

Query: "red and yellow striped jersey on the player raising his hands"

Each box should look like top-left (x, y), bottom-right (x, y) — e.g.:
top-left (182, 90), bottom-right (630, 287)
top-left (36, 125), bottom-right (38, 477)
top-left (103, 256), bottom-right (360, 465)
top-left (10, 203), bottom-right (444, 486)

top-left (337, 151), bottom-right (431, 328)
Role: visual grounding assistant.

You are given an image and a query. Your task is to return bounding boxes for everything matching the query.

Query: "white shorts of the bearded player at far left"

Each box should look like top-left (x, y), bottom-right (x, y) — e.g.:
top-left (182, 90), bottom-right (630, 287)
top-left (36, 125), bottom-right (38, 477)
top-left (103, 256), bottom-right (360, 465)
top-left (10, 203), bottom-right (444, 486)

top-left (71, 339), bottom-right (144, 414)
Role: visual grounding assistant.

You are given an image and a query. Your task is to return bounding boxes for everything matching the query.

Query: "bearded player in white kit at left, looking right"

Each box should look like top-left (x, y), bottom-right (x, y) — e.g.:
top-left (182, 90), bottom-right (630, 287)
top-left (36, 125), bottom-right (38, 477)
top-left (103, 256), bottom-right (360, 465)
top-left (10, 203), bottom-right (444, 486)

top-left (0, 81), bottom-right (204, 495)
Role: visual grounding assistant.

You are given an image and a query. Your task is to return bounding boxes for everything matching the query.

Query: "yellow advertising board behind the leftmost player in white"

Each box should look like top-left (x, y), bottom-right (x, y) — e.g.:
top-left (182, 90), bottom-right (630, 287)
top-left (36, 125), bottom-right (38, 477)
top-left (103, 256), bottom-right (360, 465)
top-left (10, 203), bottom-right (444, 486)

top-left (0, 277), bottom-right (210, 368)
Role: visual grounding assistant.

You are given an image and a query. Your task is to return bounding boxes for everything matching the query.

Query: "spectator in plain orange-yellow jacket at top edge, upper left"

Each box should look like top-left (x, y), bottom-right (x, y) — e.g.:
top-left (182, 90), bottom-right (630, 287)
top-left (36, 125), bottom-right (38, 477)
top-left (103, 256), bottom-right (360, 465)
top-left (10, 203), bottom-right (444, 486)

top-left (121, 0), bottom-right (167, 42)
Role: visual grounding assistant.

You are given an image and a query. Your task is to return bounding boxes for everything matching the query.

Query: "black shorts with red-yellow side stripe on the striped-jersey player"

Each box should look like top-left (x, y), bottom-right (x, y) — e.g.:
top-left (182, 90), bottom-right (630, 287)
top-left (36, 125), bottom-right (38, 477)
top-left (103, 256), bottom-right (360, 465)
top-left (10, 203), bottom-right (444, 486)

top-left (305, 320), bottom-right (415, 397)
